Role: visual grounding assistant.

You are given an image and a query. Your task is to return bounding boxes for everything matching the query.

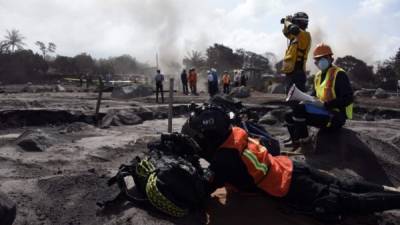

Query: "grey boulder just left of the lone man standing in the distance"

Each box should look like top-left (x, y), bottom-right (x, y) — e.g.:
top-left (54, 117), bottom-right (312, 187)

top-left (111, 84), bottom-right (153, 99)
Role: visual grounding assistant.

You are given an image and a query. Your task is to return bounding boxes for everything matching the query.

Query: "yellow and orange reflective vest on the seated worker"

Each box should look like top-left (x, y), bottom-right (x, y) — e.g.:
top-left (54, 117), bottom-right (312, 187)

top-left (314, 65), bottom-right (353, 119)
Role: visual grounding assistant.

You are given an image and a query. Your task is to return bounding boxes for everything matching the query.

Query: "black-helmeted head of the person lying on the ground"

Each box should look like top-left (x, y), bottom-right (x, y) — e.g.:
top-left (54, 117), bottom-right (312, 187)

top-left (182, 105), bottom-right (232, 159)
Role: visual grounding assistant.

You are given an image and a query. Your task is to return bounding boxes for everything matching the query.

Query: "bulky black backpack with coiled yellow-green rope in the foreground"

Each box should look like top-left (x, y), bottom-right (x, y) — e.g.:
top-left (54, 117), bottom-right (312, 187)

top-left (98, 133), bottom-right (209, 217)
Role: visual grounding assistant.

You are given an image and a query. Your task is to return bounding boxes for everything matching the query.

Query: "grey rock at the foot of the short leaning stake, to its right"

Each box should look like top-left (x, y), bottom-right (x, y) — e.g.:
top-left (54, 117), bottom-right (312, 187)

top-left (101, 109), bottom-right (143, 128)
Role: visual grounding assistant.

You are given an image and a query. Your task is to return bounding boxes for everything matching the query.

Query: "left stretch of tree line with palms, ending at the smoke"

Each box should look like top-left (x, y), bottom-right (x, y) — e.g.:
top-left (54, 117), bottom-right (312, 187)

top-left (0, 29), bottom-right (150, 84)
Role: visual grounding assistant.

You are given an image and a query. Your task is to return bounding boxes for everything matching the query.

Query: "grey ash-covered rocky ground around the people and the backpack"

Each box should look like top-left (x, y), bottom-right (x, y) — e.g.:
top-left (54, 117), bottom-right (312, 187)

top-left (0, 86), bottom-right (400, 225)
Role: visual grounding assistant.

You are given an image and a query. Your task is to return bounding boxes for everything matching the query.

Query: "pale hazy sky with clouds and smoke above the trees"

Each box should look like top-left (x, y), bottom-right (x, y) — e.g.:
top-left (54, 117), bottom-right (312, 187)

top-left (0, 0), bottom-right (400, 69)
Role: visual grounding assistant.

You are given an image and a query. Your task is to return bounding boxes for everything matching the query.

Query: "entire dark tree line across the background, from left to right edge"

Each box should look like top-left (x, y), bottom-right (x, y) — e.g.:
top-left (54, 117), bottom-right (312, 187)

top-left (0, 29), bottom-right (400, 90)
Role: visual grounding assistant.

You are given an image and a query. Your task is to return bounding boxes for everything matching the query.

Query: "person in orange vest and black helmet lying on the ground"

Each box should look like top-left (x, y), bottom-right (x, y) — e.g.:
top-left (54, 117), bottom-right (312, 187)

top-left (182, 106), bottom-right (400, 220)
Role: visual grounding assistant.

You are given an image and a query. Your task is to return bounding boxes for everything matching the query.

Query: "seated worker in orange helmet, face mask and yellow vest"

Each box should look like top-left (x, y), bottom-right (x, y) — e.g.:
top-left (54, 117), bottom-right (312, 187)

top-left (284, 43), bottom-right (353, 149)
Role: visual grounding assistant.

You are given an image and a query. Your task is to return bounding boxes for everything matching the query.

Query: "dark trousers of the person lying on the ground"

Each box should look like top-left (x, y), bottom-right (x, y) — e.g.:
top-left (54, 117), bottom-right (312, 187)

top-left (284, 161), bottom-right (400, 219)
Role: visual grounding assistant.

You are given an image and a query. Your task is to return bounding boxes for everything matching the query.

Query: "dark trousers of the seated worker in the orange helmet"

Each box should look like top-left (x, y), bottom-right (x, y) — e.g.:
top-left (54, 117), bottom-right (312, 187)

top-left (285, 104), bottom-right (346, 141)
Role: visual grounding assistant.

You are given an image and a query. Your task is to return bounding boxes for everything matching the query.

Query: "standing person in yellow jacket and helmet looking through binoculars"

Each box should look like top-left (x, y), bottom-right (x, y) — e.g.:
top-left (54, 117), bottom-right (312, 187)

top-left (281, 12), bottom-right (311, 91)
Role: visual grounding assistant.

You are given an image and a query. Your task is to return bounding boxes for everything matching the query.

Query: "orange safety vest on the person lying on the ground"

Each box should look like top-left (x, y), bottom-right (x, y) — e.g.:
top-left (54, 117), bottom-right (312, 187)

top-left (220, 127), bottom-right (293, 197)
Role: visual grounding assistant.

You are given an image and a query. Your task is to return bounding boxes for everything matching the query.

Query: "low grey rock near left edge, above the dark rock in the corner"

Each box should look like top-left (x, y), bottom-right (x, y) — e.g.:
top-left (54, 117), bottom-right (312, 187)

top-left (15, 129), bottom-right (54, 152)
